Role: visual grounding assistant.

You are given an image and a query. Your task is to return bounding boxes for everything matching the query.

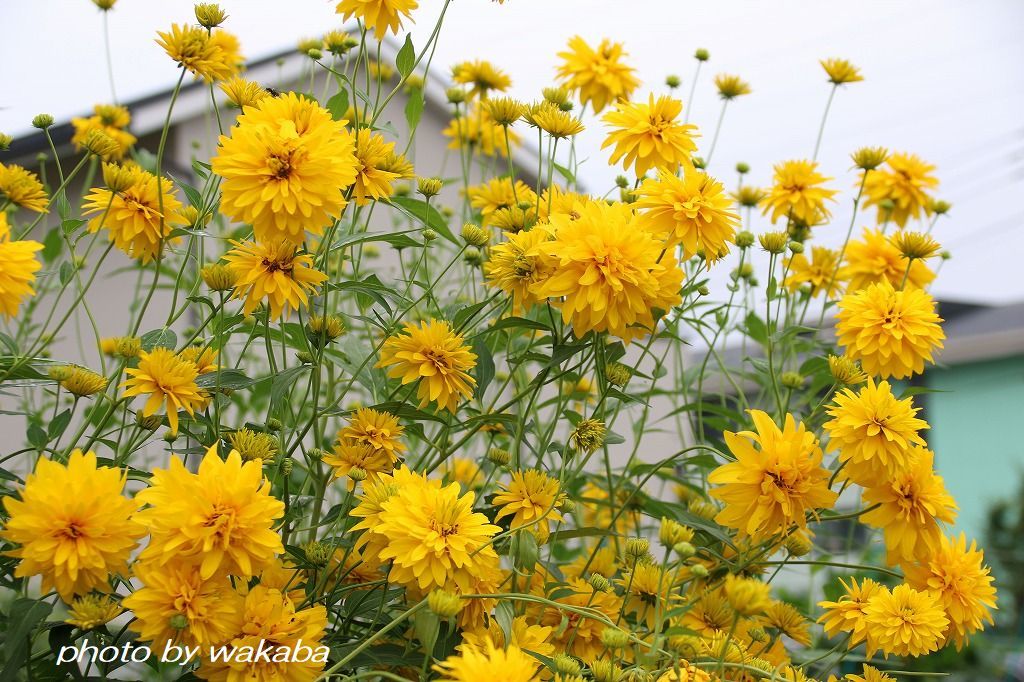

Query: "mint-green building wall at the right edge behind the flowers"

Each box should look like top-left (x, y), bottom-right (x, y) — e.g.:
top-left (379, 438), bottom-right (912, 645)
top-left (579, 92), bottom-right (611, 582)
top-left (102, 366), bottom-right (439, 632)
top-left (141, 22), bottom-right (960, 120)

top-left (916, 356), bottom-right (1024, 544)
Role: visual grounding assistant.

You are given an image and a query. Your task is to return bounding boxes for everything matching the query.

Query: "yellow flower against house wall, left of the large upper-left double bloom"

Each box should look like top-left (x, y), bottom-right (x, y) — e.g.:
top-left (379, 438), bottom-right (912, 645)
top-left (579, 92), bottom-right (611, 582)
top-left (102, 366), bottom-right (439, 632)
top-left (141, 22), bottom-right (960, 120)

top-left (82, 168), bottom-right (186, 263)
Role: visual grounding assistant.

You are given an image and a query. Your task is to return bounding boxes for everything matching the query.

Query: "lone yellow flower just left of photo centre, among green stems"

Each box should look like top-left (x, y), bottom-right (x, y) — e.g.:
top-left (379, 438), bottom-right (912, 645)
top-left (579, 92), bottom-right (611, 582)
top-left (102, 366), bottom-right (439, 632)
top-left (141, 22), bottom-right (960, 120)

top-left (376, 319), bottom-right (476, 413)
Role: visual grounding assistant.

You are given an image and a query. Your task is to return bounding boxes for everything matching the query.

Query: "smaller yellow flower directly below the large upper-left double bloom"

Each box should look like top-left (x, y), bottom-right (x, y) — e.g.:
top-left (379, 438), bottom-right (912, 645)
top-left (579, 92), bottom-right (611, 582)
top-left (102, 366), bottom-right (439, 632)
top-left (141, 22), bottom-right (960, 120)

top-left (224, 240), bottom-right (327, 319)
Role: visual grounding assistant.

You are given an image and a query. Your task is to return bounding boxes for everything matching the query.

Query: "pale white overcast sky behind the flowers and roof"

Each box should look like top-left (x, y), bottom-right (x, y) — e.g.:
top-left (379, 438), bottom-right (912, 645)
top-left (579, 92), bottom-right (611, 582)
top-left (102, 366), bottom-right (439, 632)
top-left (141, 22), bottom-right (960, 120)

top-left (0, 0), bottom-right (1024, 303)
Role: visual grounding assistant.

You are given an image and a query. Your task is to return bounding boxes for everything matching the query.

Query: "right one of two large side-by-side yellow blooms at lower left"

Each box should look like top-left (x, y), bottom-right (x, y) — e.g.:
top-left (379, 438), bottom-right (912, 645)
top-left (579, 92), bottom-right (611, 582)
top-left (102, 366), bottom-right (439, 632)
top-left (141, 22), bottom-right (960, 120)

top-left (135, 445), bottom-right (285, 580)
